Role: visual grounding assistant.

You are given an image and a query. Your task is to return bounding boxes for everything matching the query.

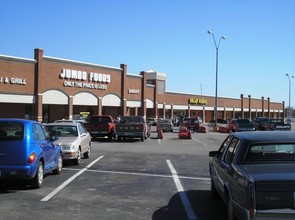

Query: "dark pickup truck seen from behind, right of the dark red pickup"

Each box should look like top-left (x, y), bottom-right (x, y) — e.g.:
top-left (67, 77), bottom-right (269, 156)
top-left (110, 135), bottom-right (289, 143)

top-left (115, 116), bottom-right (150, 141)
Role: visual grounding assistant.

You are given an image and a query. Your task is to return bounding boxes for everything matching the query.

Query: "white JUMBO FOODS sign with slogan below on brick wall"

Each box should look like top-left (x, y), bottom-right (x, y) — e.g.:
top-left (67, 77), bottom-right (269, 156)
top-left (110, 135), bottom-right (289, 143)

top-left (59, 69), bottom-right (111, 90)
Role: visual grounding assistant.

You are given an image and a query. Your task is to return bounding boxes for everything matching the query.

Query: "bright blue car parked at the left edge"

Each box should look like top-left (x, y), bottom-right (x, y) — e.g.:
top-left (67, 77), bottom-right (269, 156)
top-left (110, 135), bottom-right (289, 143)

top-left (0, 118), bottom-right (62, 189)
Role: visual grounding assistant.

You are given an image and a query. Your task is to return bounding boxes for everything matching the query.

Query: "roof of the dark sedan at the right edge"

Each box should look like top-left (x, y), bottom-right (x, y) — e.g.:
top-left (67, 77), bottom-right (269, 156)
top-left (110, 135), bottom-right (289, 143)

top-left (233, 131), bottom-right (295, 142)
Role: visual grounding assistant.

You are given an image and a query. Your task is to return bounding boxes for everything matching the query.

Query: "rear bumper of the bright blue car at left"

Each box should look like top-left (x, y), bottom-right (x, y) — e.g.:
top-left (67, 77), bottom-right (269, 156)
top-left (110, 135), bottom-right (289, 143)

top-left (0, 166), bottom-right (36, 179)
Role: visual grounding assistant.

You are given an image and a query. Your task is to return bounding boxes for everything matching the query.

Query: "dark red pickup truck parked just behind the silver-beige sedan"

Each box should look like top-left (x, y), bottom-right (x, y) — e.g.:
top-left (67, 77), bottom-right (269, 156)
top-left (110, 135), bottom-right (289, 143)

top-left (84, 115), bottom-right (115, 140)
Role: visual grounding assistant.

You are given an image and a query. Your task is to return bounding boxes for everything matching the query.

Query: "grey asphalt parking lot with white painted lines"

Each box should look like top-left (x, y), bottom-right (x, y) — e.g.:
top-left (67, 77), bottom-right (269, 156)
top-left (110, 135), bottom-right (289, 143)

top-left (0, 131), bottom-right (236, 220)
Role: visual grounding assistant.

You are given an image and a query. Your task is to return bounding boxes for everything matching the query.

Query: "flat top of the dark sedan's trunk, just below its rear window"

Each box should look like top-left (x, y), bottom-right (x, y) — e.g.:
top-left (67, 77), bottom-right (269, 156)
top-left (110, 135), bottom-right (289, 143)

top-left (241, 163), bottom-right (295, 181)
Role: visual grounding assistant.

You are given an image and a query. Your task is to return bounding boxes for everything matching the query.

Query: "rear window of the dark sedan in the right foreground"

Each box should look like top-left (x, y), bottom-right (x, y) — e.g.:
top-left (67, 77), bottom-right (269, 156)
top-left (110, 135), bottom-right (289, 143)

top-left (246, 143), bottom-right (295, 163)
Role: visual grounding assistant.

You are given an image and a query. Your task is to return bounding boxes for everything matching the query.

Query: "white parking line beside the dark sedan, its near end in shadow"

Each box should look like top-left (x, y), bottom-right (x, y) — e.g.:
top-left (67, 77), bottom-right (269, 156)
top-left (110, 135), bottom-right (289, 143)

top-left (166, 160), bottom-right (197, 220)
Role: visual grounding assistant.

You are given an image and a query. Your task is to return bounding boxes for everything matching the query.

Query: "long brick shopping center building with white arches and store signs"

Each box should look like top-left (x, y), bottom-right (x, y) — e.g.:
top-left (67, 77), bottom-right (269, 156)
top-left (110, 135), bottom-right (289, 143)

top-left (0, 49), bottom-right (285, 122)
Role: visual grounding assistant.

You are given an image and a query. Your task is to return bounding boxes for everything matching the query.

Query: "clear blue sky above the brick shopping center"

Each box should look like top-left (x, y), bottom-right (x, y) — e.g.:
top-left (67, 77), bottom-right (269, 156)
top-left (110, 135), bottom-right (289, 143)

top-left (0, 0), bottom-right (295, 106)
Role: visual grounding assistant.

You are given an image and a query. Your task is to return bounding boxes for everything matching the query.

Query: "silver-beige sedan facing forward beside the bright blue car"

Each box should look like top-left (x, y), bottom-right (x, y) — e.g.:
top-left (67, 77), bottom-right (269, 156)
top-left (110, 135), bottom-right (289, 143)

top-left (45, 122), bottom-right (92, 165)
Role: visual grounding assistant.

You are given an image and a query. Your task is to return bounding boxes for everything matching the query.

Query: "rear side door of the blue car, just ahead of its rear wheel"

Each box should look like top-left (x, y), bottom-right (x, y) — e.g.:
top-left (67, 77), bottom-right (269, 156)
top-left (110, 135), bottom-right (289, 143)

top-left (33, 123), bottom-right (55, 171)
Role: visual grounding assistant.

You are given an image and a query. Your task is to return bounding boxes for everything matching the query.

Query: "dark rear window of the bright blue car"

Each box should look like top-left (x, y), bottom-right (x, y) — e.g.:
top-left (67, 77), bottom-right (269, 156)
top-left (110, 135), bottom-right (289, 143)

top-left (0, 122), bottom-right (24, 140)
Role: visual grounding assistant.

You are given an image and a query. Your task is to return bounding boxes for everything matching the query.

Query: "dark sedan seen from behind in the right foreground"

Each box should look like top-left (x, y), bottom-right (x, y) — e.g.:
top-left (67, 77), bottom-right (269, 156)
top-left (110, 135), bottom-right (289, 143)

top-left (209, 131), bottom-right (295, 219)
